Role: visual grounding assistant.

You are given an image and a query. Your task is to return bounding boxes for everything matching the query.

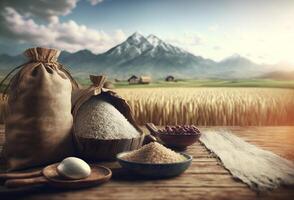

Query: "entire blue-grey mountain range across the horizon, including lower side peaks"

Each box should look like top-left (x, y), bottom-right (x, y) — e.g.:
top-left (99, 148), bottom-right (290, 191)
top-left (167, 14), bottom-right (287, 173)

top-left (0, 32), bottom-right (290, 79)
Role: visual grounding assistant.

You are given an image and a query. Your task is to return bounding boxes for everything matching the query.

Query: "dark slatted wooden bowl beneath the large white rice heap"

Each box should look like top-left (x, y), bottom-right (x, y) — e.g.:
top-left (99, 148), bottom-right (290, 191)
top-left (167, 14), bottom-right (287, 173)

top-left (75, 133), bottom-right (145, 161)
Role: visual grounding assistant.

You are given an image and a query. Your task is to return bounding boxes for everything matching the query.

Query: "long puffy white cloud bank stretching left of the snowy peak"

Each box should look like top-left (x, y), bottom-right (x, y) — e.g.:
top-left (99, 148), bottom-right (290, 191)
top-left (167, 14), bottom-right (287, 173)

top-left (0, 7), bottom-right (126, 53)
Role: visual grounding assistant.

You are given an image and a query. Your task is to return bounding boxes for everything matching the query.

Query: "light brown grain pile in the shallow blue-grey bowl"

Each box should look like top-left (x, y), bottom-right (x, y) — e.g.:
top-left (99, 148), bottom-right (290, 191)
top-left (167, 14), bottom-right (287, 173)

top-left (122, 142), bottom-right (186, 164)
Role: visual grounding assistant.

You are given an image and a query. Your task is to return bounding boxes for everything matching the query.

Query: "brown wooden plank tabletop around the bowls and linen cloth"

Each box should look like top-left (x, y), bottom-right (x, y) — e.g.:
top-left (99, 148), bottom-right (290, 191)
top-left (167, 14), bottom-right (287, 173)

top-left (0, 126), bottom-right (294, 200)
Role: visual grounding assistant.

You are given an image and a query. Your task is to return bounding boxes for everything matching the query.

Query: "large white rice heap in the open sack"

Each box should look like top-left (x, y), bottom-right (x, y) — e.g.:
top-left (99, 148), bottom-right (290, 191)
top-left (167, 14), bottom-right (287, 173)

top-left (75, 96), bottom-right (140, 140)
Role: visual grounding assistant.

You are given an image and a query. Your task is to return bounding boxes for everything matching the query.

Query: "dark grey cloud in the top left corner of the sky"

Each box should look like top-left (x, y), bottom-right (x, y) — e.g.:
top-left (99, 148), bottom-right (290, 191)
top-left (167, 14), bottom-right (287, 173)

top-left (0, 0), bottom-right (78, 20)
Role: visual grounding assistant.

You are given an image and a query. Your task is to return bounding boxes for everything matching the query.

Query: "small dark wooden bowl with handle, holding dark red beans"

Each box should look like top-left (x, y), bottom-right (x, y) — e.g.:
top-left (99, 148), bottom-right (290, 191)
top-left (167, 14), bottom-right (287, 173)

top-left (146, 123), bottom-right (200, 151)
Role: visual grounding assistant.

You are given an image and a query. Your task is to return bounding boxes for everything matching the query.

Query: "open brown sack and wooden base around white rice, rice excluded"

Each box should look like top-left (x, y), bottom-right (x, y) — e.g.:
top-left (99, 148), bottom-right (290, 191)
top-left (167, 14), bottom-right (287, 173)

top-left (72, 75), bottom-right (145, 161)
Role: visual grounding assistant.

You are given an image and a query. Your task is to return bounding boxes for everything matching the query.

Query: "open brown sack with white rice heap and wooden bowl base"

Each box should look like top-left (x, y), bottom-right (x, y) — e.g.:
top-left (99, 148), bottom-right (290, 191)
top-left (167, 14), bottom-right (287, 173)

top-left (72, 76), bottom-right (144, 160)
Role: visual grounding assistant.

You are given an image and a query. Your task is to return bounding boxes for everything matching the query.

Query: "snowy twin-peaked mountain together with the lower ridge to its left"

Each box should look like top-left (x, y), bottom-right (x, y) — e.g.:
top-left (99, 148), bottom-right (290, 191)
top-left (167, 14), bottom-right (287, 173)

top-left (60, 32), bottom-right (215, 78)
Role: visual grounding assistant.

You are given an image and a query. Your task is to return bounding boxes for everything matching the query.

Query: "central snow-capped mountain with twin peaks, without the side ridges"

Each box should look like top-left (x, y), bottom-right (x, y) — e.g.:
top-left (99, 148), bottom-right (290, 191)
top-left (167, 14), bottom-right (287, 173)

top-left (95, 32), bottom-right (214, 77)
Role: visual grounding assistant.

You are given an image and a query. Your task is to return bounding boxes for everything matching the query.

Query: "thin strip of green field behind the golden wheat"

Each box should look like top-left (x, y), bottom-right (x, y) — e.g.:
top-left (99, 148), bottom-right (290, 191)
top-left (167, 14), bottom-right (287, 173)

top-left (97, 79), bottom-right (294, 89)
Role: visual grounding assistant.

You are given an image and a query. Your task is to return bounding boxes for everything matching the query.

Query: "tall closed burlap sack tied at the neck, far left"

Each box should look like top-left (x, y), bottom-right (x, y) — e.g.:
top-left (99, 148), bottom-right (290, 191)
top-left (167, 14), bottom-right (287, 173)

top-left (1, 48), bottom-right (79, 170)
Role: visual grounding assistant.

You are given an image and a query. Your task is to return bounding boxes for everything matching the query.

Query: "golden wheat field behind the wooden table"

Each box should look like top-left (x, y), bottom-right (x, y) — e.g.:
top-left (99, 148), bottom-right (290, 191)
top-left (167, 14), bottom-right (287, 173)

top-left (116, 88), bottom-right (294, 126)
